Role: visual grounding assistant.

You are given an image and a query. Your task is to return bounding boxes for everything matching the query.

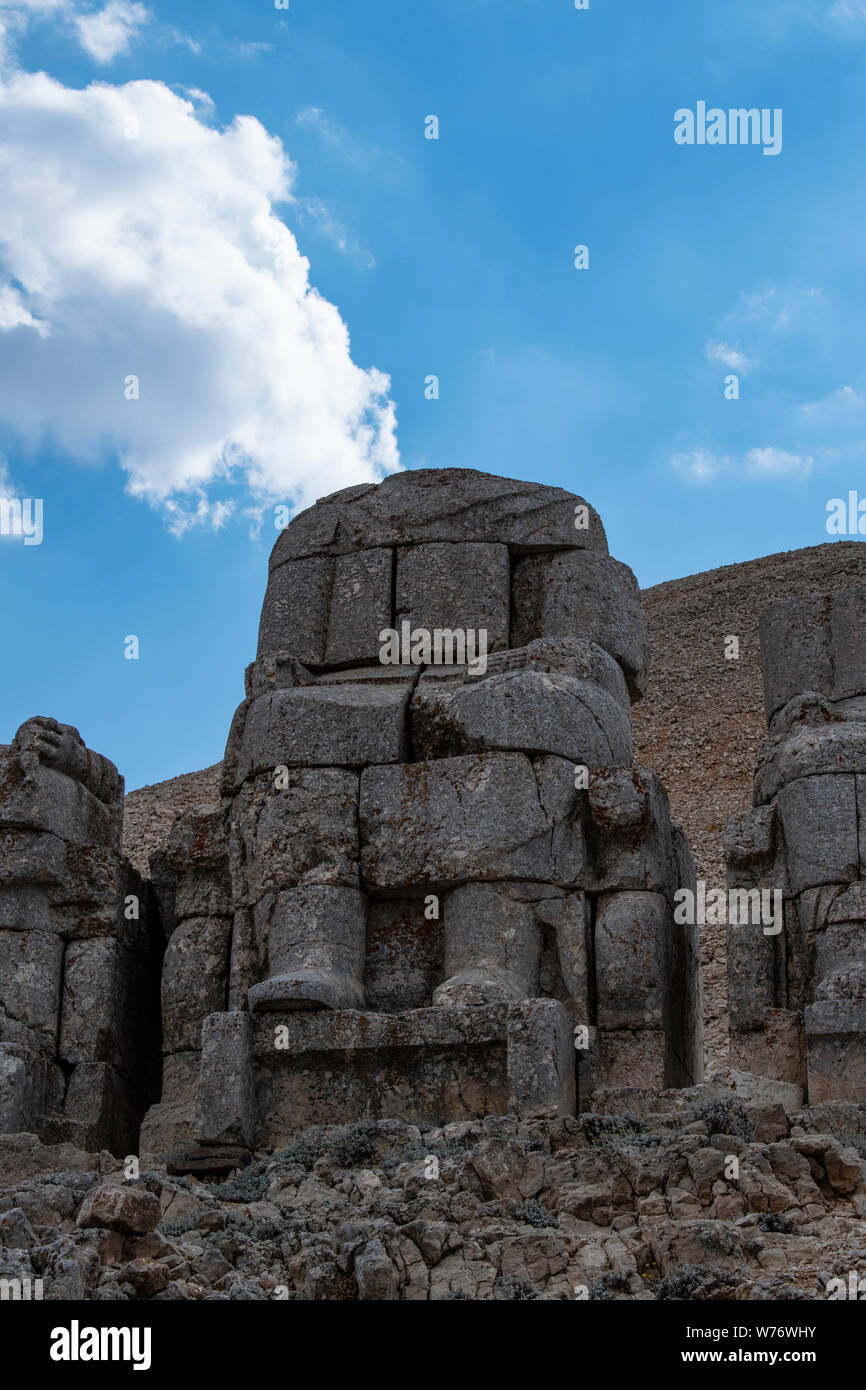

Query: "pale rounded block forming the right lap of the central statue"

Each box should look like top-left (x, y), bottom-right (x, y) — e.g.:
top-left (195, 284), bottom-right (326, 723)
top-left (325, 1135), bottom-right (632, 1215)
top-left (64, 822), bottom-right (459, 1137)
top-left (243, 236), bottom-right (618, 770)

top-left (411, 644), bottom-right (632, 767)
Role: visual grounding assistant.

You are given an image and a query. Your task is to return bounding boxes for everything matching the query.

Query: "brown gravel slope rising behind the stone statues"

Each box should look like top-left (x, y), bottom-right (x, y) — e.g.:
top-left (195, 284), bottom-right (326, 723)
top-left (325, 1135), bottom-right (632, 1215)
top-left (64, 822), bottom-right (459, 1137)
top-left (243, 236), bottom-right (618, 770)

top-left (124, 541), bottom-right (866, 1065)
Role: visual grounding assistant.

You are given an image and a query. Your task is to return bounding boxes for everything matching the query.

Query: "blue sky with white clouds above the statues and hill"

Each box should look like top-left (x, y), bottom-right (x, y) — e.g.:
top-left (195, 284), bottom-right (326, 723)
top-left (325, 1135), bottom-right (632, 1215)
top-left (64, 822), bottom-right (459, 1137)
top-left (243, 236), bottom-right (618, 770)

top-left (0, 0), bottom-right (866, 787)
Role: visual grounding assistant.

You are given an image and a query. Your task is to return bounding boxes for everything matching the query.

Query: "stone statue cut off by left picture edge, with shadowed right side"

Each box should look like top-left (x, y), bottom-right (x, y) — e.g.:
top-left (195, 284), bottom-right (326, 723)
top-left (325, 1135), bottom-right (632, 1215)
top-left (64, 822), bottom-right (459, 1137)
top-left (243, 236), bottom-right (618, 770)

top-left (0, 717), bottom-right (161, 1154)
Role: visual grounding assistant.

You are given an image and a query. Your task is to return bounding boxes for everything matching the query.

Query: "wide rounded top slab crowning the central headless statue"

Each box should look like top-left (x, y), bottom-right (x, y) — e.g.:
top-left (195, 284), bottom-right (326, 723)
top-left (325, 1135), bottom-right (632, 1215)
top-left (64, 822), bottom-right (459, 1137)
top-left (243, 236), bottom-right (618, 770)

top-left (271, 468), bottom-right (607, 570)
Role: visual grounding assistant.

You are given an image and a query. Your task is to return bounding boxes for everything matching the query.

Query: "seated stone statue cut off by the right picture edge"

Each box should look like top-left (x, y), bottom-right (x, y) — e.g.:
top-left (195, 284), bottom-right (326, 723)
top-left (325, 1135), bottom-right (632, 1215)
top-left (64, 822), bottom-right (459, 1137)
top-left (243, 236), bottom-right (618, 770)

top-left (726, 589), bottom-right (866, 1105)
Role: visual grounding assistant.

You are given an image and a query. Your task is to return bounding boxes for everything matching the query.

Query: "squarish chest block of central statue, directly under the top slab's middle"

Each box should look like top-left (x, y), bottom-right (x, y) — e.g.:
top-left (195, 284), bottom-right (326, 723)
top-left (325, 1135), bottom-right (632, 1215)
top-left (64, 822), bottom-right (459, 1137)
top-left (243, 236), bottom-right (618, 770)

top-left (395, 542), bottom-right (512, 652)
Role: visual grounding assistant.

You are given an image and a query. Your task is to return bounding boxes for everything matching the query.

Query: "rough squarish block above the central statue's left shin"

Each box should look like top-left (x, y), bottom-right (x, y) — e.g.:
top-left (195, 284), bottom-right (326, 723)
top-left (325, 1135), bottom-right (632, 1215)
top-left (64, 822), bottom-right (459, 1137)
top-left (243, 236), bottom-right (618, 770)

top-left (232, 767), bottom-right (359, 906)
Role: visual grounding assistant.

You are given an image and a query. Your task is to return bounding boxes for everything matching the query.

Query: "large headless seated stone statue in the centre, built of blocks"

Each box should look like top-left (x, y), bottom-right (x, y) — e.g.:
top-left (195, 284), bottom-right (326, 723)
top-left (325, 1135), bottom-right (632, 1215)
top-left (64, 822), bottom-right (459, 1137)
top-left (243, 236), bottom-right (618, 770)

top-left (145, 470), bottom-right (701, 1166)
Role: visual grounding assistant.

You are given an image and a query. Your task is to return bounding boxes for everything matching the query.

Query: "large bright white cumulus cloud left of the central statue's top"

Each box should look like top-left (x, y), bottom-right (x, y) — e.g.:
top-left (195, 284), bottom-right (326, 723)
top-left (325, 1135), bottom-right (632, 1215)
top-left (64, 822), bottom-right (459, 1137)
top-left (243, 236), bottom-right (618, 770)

top-left (0, 59), bottom-right (399, 531)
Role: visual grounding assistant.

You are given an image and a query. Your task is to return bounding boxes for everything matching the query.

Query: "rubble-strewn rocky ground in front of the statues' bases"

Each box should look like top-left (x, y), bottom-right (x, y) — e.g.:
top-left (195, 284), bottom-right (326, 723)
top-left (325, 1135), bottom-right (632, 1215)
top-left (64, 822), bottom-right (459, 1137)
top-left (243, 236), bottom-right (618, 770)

top-left (0, 1084), bottom-right (866, 1301)
